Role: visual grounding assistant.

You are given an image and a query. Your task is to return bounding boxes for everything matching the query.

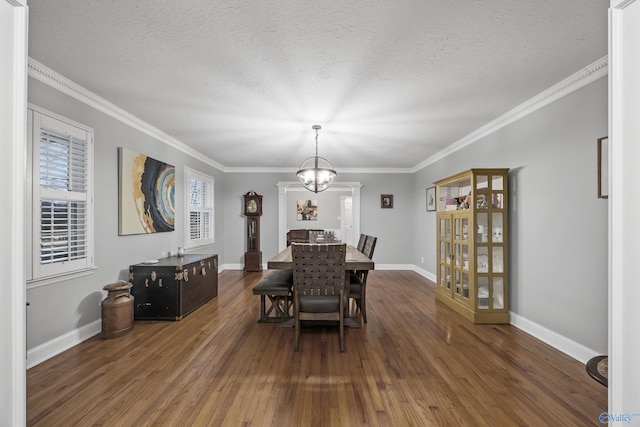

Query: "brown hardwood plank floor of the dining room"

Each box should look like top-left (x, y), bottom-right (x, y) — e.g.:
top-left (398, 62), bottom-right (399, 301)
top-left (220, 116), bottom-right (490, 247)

top-left (27, 271), bottom-right (607, 427)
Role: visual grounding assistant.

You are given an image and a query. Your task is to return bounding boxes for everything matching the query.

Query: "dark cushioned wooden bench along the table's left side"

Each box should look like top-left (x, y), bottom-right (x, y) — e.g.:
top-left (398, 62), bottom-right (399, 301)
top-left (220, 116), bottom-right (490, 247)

top-left (253, 270), bottom-right (293, 323)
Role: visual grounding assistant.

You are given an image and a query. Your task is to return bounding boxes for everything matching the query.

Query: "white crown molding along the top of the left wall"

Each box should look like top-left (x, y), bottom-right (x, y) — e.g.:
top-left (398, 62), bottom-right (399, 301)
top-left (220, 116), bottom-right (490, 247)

top-left (28, 58), bottom-right (225, 171)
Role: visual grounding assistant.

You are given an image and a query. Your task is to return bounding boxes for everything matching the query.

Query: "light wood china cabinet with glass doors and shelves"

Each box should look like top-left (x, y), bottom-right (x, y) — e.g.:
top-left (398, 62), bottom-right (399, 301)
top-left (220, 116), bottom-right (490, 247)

top-left (434, 169), bottom-right (509, 323)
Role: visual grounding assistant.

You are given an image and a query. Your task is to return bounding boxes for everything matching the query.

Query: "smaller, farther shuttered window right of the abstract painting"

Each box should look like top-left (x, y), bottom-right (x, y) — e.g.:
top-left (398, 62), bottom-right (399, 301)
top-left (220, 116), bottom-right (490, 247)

top-left (185, 168), bottom-right (215, 248)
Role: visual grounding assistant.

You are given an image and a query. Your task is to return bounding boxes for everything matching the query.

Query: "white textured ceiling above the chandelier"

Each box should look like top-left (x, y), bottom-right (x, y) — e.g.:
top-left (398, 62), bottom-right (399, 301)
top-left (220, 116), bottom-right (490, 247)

top-left (28, 0), bottom-right (609, 173)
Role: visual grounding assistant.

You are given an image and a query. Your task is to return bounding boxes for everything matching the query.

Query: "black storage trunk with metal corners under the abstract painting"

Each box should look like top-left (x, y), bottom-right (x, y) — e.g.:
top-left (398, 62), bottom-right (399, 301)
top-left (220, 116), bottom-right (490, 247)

top-left (129, 254), bottom-right (218, 320)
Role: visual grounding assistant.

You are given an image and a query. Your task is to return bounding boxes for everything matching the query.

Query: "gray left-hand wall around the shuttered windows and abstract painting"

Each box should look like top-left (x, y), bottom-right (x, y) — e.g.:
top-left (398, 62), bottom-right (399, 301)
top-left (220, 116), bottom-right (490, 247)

top-left (27, 79), bottom-right (224, 349)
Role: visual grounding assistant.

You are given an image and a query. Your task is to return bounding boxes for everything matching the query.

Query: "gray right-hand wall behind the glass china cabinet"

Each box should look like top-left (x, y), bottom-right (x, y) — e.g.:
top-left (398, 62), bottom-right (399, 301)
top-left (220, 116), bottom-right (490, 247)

top-left (411, 78), bottom-right (608, 354)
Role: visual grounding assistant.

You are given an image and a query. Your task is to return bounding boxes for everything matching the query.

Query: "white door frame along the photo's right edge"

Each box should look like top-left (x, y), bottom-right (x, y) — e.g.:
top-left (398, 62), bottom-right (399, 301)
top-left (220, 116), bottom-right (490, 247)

top-left (608, 0), bottom-right (640, 414)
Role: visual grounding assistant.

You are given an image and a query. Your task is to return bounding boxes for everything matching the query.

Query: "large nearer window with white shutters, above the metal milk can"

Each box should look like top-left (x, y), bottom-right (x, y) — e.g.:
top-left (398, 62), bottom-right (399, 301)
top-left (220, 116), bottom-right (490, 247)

top-left (27, 109), bottom-right (93, 281)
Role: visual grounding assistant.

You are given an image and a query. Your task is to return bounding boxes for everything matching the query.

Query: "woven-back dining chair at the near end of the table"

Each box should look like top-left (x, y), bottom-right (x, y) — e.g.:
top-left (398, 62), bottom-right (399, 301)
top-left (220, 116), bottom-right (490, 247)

top-left (291, 243), bottom-right (347, 351)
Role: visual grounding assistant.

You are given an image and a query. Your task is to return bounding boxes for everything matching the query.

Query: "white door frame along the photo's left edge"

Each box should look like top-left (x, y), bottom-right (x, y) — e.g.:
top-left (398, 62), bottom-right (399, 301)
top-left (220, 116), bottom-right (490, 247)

top-left (0, 0), bottom-right (29, 426)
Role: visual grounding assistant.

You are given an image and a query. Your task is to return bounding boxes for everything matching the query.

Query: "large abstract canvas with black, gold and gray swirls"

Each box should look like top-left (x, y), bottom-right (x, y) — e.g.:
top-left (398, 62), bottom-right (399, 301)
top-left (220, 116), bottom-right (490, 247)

top-left (118, 147), bottom-right (176, 236)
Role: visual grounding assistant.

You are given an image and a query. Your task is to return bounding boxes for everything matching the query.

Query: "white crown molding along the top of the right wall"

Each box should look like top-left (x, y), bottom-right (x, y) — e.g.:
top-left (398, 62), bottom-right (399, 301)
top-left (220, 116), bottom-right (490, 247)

top-left (411, 56), bottom-right (609, 172)
